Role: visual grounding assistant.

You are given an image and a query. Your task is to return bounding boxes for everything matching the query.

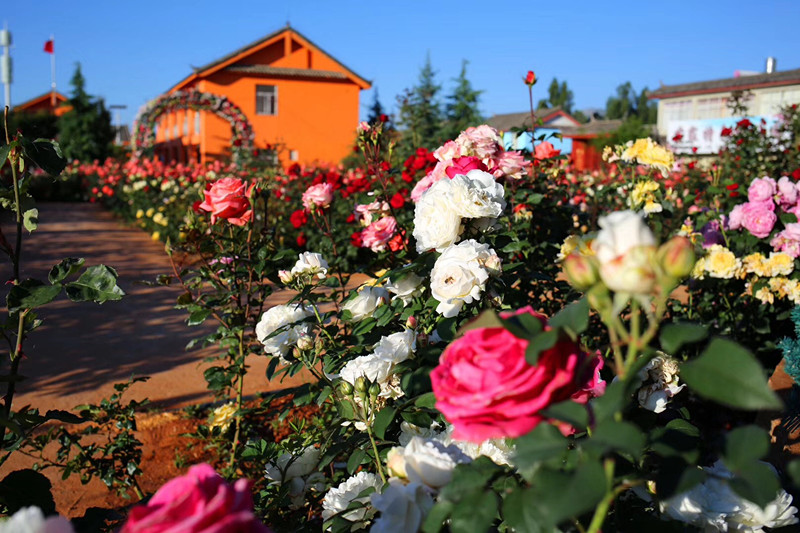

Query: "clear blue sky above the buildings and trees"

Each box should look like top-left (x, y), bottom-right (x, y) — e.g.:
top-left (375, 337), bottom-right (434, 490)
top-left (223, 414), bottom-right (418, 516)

top-left (0, 0), bottom-right (800, 128)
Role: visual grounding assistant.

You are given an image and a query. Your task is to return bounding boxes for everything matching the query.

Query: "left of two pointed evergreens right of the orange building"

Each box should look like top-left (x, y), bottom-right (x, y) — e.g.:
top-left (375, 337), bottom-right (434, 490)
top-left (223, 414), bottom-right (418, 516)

top-left (398, 54), bottom-right (442, 151)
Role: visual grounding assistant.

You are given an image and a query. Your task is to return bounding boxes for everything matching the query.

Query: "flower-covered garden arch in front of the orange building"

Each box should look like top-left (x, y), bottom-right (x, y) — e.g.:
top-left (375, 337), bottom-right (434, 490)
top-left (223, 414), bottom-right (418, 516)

top-left (132, 90), bottom-right (255, 163)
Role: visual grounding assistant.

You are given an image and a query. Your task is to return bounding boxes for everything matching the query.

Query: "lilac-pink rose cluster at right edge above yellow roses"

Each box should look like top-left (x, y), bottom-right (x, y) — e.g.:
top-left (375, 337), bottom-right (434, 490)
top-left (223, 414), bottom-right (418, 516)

top-left (728, 176), bottom-right (800, 258)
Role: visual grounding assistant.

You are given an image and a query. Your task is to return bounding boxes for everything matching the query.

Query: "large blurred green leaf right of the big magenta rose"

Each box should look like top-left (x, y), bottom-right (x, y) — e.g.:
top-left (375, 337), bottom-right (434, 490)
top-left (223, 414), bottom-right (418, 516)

top-left (681, 338), bottom-right (783, 411)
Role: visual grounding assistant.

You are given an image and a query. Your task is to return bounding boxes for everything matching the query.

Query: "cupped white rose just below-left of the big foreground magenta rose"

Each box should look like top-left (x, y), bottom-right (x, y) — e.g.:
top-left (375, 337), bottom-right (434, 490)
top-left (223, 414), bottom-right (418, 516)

top-left (403, 437), bottom-right (471, 490)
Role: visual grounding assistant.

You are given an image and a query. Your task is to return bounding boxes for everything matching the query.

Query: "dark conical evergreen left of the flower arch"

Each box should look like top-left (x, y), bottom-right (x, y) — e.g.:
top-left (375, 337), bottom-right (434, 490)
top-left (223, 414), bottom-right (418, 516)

top-left (59, 63), bottom-right (114, 161)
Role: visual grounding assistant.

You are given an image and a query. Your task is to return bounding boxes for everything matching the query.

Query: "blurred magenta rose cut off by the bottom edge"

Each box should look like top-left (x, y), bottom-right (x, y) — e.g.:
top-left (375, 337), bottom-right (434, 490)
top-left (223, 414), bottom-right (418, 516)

top-left (121, 464), bottom-right (270, 533)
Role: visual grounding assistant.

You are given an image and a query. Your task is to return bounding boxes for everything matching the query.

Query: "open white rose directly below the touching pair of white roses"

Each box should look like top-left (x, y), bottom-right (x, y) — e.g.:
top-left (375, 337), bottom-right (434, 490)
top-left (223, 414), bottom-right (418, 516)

top-left (431, 239), bottom-right (496, 318)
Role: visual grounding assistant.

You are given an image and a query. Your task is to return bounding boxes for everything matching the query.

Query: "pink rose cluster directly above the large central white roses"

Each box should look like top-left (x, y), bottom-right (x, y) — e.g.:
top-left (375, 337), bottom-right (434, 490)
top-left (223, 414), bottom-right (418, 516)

top-left (411, 124), bottom-right (526, 202)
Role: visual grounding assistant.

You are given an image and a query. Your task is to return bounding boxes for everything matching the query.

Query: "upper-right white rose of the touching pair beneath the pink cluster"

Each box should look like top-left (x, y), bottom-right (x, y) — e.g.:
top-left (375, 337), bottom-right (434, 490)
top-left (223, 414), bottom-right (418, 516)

top-left (450, 170), bottom-right (506, 218)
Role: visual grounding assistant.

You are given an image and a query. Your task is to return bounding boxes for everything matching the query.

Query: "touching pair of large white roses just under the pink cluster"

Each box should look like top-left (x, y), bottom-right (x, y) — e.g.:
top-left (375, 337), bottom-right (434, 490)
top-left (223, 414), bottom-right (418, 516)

top-left (414, 170), bottom-right (506, 253)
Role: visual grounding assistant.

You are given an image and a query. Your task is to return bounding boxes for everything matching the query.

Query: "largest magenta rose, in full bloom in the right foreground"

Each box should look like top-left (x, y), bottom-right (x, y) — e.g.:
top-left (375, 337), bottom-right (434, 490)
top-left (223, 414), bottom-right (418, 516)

top-left (431, 307), bottom-right (605, 442)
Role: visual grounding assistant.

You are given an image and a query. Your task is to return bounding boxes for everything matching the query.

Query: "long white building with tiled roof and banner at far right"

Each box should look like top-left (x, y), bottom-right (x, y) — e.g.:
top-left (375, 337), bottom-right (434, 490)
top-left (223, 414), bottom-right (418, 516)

top-left (648, 65), bottom-right (800, 154)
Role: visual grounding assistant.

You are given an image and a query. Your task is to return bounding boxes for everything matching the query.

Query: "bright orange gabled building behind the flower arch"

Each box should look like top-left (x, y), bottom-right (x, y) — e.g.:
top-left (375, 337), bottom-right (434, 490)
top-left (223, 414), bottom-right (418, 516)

top-left (155, 26), bottom-right (371, 165)
